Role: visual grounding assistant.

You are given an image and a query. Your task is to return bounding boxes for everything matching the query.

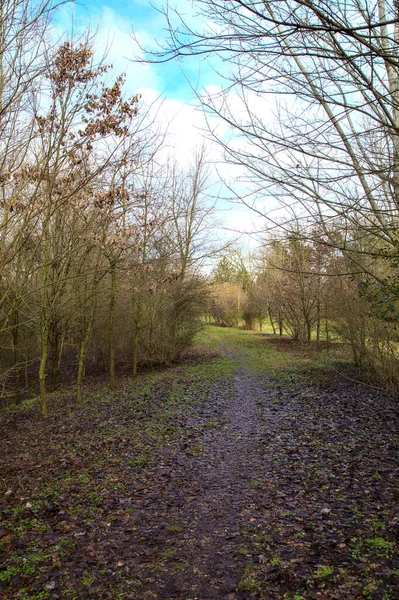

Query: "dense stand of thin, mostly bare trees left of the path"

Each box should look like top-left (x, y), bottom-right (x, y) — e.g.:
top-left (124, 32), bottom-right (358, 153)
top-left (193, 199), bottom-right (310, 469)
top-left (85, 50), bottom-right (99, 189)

top-left (0, 0), bottom-right (216, 417)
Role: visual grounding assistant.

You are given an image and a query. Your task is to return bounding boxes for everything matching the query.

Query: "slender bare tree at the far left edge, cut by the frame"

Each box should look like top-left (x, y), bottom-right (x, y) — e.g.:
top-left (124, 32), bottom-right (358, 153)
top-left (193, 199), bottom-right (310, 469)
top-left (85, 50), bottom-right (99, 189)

top-left (0, 0), bottom-right (73, 406)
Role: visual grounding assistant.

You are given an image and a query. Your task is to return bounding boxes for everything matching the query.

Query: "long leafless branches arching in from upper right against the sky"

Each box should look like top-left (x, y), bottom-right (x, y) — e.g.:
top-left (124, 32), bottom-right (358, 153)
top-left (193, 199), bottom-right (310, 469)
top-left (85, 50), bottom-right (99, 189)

top-left (148, 0), bottom-right (399, 280)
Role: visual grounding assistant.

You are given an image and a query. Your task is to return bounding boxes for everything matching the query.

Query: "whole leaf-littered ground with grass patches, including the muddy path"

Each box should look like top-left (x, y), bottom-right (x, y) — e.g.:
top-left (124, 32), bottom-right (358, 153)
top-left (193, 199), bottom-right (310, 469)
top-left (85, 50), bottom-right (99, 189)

top-left (0, 336), bottom-right (399, 600)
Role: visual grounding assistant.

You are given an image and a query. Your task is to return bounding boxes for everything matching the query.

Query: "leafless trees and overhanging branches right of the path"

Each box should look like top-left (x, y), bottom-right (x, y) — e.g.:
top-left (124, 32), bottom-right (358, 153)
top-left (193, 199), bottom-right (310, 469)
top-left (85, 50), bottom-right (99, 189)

top-left (152, 0), bottom-right (399, 390)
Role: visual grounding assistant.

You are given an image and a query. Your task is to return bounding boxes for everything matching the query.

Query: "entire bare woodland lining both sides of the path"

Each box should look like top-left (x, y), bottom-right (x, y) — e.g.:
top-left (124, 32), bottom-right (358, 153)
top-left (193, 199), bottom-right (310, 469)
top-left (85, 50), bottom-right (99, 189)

top-left (0, 0), bottom-right (399, 417)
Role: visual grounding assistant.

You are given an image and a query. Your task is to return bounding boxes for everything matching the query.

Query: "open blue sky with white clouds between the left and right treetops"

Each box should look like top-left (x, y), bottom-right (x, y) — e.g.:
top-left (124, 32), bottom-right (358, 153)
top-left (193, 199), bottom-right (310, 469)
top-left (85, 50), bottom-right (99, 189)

top-left (58, 0), bottom-right (260, 245)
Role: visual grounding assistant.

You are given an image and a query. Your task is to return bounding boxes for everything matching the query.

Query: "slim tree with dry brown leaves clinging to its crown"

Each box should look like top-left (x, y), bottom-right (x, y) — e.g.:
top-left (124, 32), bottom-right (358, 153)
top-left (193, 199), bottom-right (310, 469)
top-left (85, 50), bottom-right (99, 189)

top-left (33, 40), bottom-right (139, 417)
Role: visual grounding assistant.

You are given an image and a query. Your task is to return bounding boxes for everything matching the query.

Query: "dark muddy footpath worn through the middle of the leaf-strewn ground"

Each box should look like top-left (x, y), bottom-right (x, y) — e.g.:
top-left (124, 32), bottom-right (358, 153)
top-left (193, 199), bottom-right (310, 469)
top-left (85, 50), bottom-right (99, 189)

top-left (130, 356), bottom-right (270, 600)
